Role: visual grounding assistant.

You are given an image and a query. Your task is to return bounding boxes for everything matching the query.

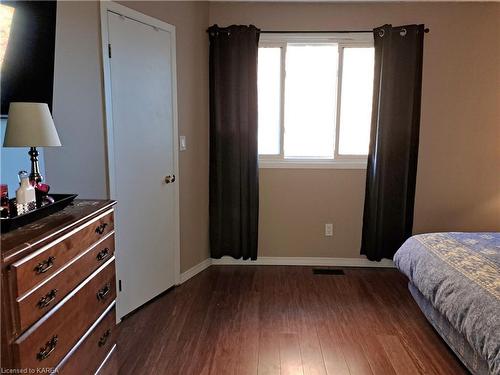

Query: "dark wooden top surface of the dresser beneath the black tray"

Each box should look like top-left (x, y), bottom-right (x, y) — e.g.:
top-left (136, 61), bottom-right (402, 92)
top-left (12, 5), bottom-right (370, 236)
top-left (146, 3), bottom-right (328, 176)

top-left (0, 199), bottom-right (116, 265)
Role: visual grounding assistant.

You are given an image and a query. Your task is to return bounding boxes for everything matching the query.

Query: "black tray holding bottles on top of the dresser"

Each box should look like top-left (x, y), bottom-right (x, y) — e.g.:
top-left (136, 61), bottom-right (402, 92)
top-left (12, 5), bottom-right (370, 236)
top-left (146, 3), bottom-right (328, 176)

top-left (1, 194), bottom-right (78, 233)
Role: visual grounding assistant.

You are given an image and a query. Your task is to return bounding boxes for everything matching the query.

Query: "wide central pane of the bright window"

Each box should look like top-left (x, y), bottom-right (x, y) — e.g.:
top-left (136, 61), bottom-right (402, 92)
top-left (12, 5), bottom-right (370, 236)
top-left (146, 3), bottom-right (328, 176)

top-left (284, 44), bottom-right (338, 158)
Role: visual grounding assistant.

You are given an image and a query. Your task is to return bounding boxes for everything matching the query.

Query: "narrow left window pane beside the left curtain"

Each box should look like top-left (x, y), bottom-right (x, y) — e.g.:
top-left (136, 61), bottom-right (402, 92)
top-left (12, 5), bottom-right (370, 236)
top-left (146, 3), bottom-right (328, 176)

top-left (257, 47), bottom-right (281, 155)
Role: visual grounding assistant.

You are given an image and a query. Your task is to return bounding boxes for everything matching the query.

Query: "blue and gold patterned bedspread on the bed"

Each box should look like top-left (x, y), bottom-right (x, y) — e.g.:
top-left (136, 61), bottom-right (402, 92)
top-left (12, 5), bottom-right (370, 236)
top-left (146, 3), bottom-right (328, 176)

top-left (394, 232), bottom-right (500, 375)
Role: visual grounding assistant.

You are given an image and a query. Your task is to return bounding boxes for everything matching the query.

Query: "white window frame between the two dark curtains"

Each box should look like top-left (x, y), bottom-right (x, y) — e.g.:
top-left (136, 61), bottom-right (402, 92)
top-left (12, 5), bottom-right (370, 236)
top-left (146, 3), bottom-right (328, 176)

top-left (259, 33), bottom-right (373, 169)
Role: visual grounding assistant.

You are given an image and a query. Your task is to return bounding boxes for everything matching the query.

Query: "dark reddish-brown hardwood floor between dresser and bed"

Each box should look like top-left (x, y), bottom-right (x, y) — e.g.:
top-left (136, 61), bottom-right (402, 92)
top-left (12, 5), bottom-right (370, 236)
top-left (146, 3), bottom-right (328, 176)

top-left (118, 266), bottom-right (467, 375)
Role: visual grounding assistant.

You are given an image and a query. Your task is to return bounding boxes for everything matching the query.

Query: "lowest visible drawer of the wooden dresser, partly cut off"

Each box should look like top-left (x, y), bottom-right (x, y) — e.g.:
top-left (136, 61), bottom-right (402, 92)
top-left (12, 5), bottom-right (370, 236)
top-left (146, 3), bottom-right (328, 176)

top-left (56, 303), bottom-right (116, 375)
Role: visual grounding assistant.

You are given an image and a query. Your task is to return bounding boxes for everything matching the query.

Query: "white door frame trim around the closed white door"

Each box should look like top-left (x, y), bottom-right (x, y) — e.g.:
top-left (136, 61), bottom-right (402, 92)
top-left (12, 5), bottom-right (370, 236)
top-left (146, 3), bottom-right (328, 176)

top-left (100, 1), bottom-right (180, 285)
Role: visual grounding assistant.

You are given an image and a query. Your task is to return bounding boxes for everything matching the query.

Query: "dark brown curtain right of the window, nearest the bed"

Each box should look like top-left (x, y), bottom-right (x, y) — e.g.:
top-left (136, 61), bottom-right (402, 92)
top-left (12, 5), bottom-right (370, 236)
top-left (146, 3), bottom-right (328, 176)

top-left (361, 25), bottom-right (424, 261)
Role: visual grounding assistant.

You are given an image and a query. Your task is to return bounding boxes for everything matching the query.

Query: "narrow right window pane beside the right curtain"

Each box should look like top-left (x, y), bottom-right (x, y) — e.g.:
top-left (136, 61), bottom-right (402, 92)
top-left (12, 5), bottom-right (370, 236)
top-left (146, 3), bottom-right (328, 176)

top-left (339, 48), bottom-right (374, 155)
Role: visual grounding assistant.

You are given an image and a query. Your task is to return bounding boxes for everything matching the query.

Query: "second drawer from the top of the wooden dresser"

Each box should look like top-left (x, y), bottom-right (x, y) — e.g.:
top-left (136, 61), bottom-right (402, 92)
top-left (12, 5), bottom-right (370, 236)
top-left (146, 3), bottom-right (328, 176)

top-left (14, 234), bottom-right (115, 332)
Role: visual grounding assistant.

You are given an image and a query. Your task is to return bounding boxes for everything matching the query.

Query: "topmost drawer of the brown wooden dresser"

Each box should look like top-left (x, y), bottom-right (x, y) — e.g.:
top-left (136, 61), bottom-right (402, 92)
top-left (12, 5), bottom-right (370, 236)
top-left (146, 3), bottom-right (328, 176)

top-left (9, 211), bottom-right (114, 298)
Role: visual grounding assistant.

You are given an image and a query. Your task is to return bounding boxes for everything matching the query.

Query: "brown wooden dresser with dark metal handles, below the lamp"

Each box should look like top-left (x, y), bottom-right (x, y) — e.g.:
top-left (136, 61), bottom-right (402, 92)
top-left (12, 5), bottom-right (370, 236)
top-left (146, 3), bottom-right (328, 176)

top-left (1, 200), bottom-right (118, 375)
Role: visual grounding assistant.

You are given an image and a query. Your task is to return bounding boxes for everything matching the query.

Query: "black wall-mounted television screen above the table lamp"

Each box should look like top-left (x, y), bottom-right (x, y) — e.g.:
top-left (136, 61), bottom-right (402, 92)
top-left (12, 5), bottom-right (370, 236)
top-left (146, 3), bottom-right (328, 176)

top-left (1, 1), bottom-right (57, 115)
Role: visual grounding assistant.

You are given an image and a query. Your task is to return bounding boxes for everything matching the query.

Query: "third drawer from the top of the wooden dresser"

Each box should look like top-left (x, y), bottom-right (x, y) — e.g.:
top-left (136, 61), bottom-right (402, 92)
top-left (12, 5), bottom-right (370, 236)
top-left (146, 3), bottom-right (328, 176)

top-left (13, 258), bottom-right (116, 368)
